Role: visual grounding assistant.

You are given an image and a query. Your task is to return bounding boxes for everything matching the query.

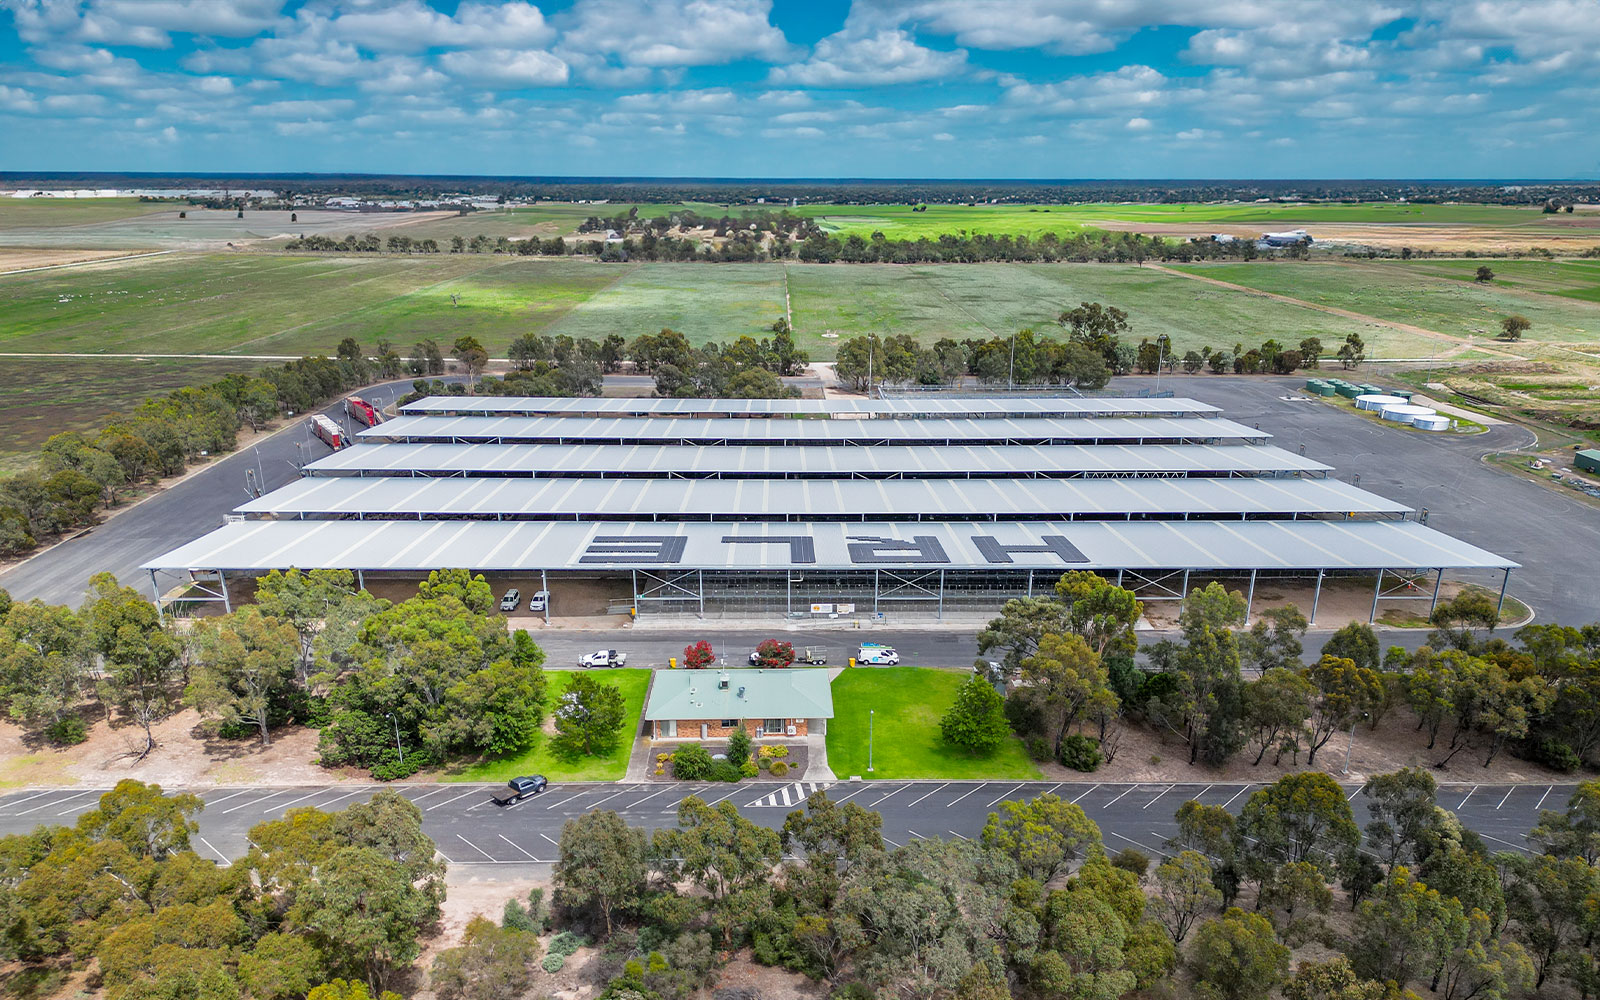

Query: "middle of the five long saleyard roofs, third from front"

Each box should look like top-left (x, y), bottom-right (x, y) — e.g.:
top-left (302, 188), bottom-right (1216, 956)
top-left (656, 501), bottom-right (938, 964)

top-left (306, 445), bottom-right (1330, 478)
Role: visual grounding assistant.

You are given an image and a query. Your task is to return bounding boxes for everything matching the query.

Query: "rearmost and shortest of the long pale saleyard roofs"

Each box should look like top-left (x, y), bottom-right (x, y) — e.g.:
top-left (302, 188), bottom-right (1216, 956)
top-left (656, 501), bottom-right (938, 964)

top-left (400, 395), bottom-right (1221, 418)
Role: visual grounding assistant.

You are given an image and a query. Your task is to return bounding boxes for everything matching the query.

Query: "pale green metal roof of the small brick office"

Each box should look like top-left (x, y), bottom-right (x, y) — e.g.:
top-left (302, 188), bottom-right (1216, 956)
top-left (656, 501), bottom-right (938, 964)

top-left (645, 667), bottom-right (834, 722)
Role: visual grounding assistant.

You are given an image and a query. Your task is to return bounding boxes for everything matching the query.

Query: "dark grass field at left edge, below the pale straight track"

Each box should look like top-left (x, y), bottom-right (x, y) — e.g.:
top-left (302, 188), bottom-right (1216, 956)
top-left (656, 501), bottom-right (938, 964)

top-left (0, 357), bottom-right (258, 475)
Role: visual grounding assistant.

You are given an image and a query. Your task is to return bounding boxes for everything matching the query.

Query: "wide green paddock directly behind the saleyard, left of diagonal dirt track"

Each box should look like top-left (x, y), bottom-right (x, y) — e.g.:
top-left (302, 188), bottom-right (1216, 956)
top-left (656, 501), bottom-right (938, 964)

top-left (0, 254), bottom-right (1465, 360)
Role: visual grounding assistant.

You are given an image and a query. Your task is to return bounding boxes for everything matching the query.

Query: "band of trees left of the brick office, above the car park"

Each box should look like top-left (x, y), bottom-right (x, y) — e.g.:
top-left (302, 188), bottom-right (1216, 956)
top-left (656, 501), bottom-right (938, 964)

top-left (0, 570), bottom-right (627, 781)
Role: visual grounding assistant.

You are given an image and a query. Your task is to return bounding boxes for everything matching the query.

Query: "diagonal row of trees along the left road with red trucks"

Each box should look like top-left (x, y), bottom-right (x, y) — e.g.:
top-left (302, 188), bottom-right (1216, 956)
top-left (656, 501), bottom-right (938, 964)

top-left (0, 348), bottom-right (378, 557)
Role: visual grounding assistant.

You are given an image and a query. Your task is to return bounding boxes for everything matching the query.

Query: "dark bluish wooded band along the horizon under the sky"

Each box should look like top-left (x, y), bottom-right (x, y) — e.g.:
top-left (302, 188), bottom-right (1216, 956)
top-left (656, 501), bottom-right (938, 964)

top-left (12, 171), bottom-right (1600, 206)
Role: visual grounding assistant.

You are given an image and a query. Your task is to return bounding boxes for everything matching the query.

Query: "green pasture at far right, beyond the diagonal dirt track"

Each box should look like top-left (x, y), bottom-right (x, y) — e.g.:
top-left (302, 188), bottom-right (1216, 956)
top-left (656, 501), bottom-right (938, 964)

top-left (1179, 261), bottom-right (1600, 342)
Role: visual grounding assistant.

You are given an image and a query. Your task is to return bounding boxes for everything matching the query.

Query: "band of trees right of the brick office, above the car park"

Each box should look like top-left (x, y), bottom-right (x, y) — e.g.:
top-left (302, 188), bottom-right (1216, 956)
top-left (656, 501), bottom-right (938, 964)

top-left (972, 571), bottom-right (1600, 771)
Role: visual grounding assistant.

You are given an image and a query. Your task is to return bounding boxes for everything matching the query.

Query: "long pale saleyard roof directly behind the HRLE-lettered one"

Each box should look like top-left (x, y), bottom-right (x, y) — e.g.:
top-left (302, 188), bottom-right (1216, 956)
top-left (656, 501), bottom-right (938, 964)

top-left (238, 477), bottom-right (1410, 522)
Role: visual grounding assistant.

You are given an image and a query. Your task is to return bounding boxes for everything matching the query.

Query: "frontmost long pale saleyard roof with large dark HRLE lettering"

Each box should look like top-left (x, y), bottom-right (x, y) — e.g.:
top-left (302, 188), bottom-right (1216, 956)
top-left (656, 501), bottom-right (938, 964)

top-left (146, 520), bottom-right (1517, 573)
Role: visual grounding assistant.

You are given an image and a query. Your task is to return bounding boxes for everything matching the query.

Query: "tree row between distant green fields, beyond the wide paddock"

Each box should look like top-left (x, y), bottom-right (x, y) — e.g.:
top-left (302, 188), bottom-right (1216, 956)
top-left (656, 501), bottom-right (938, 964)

top-left (283, 228), bottom-right (1286, 264)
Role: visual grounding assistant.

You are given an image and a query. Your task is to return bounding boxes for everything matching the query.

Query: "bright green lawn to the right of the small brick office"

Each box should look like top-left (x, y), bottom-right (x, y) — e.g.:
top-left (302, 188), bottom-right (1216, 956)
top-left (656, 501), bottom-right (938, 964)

top-left (827, 667), bottom-right (1038, 779)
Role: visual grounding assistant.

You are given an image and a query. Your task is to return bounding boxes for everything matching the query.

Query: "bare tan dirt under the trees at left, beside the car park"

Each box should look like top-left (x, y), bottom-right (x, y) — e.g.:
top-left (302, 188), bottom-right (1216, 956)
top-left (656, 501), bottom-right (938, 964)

top-left (0, 709), bottom-right (340, 789)
